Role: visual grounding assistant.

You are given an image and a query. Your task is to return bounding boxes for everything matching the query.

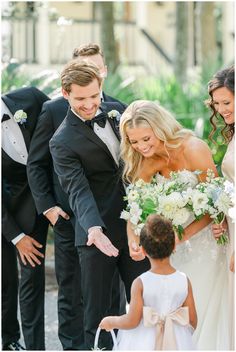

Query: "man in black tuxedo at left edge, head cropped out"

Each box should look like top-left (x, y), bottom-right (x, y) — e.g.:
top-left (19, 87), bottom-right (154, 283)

top-left (1, 87), bottom-right (49, 350)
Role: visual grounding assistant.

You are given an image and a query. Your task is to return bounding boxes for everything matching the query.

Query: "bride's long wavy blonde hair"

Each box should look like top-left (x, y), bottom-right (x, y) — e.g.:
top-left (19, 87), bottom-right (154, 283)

top-left (120, 100), bottom-right (194, 183)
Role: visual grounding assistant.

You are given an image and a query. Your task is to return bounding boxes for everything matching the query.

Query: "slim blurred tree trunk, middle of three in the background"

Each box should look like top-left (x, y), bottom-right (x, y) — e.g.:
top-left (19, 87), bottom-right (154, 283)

top-left (175, 2), bottom-right (188, 84)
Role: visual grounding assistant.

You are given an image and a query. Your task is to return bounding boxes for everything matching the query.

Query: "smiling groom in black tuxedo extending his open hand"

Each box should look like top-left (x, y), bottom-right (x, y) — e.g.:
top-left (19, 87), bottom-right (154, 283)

top-left (50, 61), bottom-right (149, 349)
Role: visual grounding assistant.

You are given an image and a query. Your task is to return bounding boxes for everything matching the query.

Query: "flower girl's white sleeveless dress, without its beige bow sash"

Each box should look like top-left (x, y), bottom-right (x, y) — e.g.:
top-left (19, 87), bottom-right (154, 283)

top-left (117, 271), bottom-right (195, 351)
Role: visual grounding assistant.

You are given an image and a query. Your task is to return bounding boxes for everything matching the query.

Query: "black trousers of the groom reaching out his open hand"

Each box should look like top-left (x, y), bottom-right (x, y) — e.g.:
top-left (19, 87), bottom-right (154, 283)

top-left (78, 243), bottom-right (150, 350)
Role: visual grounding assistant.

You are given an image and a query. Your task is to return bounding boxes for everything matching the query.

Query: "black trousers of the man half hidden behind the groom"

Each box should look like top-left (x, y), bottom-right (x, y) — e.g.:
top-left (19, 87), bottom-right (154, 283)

top-left (53, 216), bottom-right (84, 350)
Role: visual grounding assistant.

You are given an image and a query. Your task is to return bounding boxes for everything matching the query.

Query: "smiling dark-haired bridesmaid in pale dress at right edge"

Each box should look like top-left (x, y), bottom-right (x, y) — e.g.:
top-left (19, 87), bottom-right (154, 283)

top-left (207, 66), bottom-right (235, 350)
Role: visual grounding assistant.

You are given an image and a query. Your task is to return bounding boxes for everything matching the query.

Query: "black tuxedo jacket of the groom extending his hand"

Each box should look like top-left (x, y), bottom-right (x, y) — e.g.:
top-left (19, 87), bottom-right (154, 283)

top-left (50, 102), bottom-right (126, 248)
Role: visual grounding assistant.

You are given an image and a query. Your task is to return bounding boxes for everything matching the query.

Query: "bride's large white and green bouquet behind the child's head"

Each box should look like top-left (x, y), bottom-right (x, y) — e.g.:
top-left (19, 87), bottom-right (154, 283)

top-left (121, 170), bottom-right (198, 239)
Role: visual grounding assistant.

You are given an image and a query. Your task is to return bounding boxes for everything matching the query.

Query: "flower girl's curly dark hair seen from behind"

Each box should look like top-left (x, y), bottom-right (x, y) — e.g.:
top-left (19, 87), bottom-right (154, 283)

top-left (140, 214), bottom-right (175, 259)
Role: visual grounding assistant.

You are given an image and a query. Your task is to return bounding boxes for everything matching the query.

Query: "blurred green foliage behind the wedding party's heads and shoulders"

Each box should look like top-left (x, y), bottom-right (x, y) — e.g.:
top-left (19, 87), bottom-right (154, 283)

top-left (2, 59), bottom-right (226, 169)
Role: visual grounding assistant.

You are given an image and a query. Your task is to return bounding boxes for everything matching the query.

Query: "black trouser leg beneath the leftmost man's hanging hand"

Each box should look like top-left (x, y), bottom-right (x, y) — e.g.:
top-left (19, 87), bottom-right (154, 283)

top-left (19, 216), bottom-right (48, 350)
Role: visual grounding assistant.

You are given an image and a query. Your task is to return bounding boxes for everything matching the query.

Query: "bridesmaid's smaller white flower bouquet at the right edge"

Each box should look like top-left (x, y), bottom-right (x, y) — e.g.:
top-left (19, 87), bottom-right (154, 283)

top-left (191, 170), bottom-right (235, 244)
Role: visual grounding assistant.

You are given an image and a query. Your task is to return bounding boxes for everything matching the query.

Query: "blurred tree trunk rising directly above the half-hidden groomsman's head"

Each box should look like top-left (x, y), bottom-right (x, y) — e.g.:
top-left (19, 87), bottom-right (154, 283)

top-left (97, 1), bottom-right (119, 72)
